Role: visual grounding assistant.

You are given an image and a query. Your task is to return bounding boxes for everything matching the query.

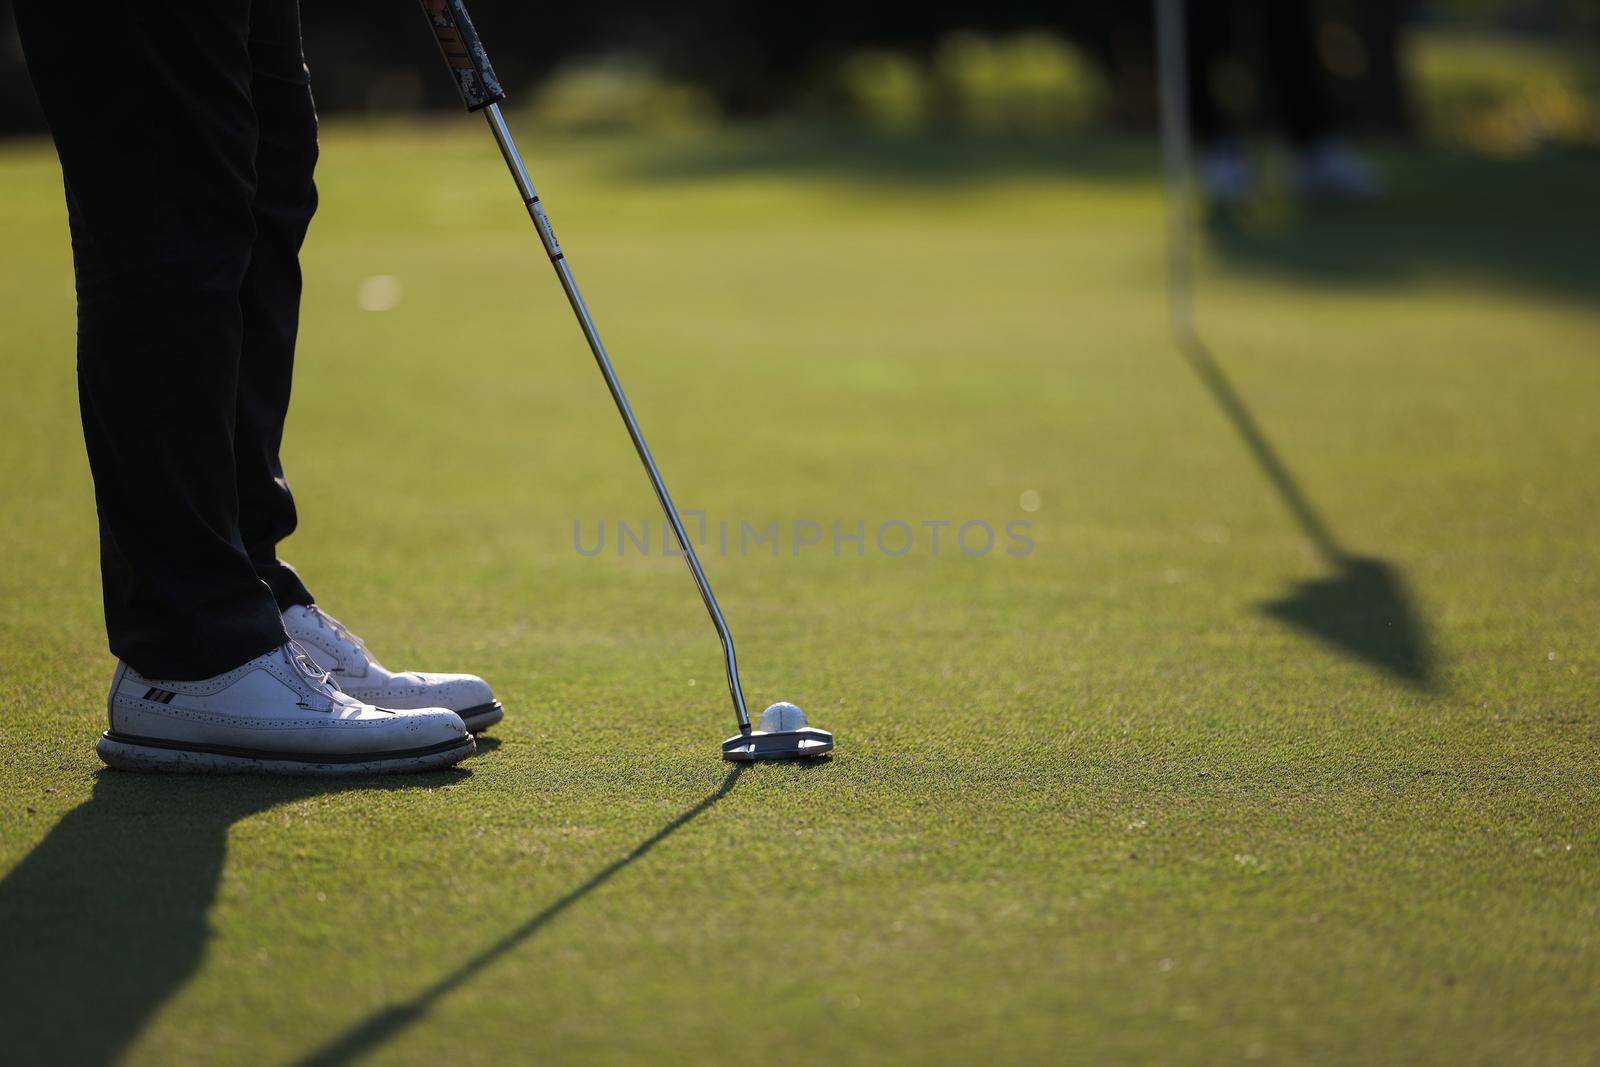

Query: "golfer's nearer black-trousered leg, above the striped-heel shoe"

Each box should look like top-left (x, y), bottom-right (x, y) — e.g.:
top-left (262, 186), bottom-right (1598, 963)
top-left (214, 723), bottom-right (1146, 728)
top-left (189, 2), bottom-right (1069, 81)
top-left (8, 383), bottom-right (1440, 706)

top-left (16, 0), bottom-right (285, 678)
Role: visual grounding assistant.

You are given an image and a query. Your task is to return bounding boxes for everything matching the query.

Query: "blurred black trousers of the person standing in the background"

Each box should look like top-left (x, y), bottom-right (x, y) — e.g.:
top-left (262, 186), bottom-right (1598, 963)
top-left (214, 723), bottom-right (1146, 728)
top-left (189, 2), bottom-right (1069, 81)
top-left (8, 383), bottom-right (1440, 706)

top-left (1187, 0), bottom-right (1331, 147)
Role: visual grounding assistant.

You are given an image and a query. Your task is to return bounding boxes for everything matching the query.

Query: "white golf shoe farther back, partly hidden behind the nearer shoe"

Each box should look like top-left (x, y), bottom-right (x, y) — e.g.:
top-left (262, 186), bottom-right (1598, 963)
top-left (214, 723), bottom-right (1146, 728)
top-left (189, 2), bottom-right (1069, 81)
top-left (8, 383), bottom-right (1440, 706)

top-left (283, 605), bottom-right (506, 733)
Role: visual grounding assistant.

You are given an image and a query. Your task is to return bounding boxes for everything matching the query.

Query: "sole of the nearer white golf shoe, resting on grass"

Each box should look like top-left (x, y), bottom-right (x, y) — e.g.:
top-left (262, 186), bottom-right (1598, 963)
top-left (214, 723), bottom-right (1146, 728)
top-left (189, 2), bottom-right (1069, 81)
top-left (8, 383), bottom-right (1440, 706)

top-left (94, 731), bottom-right (478, 777)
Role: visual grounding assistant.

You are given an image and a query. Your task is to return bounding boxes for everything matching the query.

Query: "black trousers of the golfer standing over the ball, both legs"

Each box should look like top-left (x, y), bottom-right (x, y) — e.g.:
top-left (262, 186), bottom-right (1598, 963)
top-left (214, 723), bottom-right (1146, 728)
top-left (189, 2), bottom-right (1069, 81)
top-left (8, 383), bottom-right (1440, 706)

top-left (16, 0), bottom-right (317, 678)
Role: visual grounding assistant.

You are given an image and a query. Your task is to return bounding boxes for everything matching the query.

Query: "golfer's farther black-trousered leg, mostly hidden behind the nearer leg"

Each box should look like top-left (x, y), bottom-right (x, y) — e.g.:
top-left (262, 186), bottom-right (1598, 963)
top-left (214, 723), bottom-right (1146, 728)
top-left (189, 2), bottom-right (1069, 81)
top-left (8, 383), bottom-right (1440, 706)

top-left (234, 0), bottom-right (317, 609)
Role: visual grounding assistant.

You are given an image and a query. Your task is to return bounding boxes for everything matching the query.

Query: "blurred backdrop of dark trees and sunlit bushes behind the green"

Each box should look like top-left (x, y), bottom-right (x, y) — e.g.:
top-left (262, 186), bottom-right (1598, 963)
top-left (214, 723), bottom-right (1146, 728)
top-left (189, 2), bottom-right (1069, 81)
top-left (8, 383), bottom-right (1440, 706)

top-left (0, 0), bottom-right (1600, 154)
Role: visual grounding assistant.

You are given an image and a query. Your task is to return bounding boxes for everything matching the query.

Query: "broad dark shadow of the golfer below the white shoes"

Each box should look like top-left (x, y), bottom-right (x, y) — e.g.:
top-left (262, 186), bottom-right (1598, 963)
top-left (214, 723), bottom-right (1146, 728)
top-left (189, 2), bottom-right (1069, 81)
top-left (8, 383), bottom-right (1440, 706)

top-left (0, 771), bottom-right (470, 1064)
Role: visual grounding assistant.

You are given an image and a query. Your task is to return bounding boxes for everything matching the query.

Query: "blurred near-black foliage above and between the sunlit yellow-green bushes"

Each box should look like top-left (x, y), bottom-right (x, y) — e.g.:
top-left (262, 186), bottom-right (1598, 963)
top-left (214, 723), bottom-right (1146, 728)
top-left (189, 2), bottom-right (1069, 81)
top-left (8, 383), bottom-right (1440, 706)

top-left (0, 0), bottom-right (1600, 133)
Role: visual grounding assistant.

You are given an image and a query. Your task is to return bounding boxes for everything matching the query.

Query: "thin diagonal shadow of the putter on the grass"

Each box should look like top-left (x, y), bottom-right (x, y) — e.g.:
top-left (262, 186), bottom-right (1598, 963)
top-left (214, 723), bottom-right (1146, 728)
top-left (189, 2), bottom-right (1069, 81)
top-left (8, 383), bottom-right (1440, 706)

top-left (298, 765), bottom-right (744, 1067)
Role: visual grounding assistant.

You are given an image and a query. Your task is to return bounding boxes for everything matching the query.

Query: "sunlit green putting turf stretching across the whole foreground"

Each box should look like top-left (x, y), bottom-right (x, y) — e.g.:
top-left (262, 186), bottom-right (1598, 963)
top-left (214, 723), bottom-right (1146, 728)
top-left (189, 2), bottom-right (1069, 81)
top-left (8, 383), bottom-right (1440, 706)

top-left (0, 120), bottom-right (1600, 1064)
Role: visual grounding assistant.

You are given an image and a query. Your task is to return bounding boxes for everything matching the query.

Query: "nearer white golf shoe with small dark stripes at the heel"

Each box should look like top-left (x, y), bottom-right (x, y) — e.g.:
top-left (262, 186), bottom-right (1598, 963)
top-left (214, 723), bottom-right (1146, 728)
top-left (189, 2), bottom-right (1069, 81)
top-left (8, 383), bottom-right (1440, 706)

top-left (94, 641), bottom-right (477, 774)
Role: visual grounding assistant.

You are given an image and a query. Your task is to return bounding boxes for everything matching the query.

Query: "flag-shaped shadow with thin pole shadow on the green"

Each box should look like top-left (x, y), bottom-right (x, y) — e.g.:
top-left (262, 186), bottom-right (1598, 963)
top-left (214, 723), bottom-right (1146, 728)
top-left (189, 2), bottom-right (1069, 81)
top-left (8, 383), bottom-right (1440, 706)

top-left (1178, 336), bottom-right (1432, 689)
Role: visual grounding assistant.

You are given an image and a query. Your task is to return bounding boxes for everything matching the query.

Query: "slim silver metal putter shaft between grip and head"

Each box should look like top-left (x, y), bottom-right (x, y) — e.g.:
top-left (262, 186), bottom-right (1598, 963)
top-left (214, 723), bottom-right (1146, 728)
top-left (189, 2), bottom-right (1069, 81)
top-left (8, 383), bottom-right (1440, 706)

top-left (482, 102), bottom-right (750, 734)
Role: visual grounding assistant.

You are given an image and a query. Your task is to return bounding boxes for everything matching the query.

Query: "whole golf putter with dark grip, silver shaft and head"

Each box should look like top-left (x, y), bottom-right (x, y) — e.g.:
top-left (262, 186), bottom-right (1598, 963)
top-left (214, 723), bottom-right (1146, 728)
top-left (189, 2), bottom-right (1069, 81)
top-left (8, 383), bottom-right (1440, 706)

top-left (421, 0), bottom-right (834, 761)
